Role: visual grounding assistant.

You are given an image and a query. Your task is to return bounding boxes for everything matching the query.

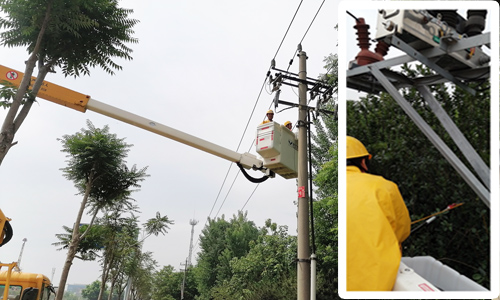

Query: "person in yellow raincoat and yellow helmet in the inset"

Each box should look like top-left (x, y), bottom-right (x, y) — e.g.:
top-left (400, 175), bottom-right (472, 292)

top-left (346, 136), bottom-right (411, 291)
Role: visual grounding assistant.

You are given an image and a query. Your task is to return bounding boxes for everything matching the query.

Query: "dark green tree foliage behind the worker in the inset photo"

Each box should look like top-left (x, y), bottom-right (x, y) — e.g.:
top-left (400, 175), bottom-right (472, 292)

top-left (347, 66), bottom-right (490, 287)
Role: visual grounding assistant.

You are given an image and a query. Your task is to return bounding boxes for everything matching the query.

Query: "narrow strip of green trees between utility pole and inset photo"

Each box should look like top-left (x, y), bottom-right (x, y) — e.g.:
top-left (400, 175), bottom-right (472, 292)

top-left (311, 55), bottom-right (339, 300)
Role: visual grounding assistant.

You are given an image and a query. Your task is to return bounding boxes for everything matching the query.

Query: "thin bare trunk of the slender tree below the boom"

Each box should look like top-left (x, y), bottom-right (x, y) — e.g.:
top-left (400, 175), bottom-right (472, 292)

top-left (55, 175), bottom-right (92, 300)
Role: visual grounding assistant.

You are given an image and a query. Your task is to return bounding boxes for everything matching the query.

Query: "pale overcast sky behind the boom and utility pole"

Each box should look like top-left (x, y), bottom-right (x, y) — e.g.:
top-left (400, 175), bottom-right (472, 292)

top-left (0, 0), bottom-right (338, 286)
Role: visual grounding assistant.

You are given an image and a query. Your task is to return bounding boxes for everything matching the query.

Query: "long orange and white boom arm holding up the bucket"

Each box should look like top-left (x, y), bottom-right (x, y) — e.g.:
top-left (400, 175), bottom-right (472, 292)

top-left (0, 65), bottom-right (274, 177)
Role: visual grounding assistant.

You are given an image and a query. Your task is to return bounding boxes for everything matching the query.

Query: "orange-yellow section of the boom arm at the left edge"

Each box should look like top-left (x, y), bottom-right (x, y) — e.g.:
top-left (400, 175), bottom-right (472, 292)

top-left (0, 65), bottom-right (90, 112)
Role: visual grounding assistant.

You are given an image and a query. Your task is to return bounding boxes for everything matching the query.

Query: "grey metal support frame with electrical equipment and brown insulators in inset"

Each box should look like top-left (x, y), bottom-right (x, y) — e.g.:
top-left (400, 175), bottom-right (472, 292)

top-left (347, 10), bottom-right (491, 207)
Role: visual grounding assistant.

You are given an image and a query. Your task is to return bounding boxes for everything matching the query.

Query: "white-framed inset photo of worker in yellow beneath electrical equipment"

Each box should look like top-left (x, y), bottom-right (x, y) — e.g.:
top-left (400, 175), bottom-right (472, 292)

top-left (339, 1), bottom-right (500, 299)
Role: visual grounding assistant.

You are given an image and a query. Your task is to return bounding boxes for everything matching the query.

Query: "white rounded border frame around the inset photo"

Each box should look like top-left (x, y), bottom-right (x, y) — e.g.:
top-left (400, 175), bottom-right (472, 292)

top-left (338, 0), bottom-right (500, 299)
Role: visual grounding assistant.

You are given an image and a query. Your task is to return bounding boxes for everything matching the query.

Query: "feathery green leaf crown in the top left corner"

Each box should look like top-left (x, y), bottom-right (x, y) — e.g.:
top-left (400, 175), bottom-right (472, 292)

top-left (0, 0), bottom-right (138, 76)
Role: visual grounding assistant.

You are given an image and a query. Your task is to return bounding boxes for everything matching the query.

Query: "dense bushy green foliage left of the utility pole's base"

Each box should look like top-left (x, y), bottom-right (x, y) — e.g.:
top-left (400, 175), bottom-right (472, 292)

top-left (152, 212), bottom-right (297, 300)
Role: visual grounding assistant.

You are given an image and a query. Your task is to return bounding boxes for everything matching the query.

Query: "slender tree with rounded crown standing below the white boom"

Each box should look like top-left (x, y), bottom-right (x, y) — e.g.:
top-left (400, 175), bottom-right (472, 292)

top-left (56, 121), bottom-right (147, 300)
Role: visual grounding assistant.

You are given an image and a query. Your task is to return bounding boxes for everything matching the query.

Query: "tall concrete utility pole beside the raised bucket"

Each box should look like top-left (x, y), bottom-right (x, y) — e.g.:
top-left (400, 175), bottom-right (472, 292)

top-left (297, 51), bottom-right (311, 300)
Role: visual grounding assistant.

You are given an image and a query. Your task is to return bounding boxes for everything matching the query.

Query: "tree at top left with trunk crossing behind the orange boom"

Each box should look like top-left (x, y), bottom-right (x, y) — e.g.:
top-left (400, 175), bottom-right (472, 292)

top-left (0, 0), bottom-right (138, 164)
